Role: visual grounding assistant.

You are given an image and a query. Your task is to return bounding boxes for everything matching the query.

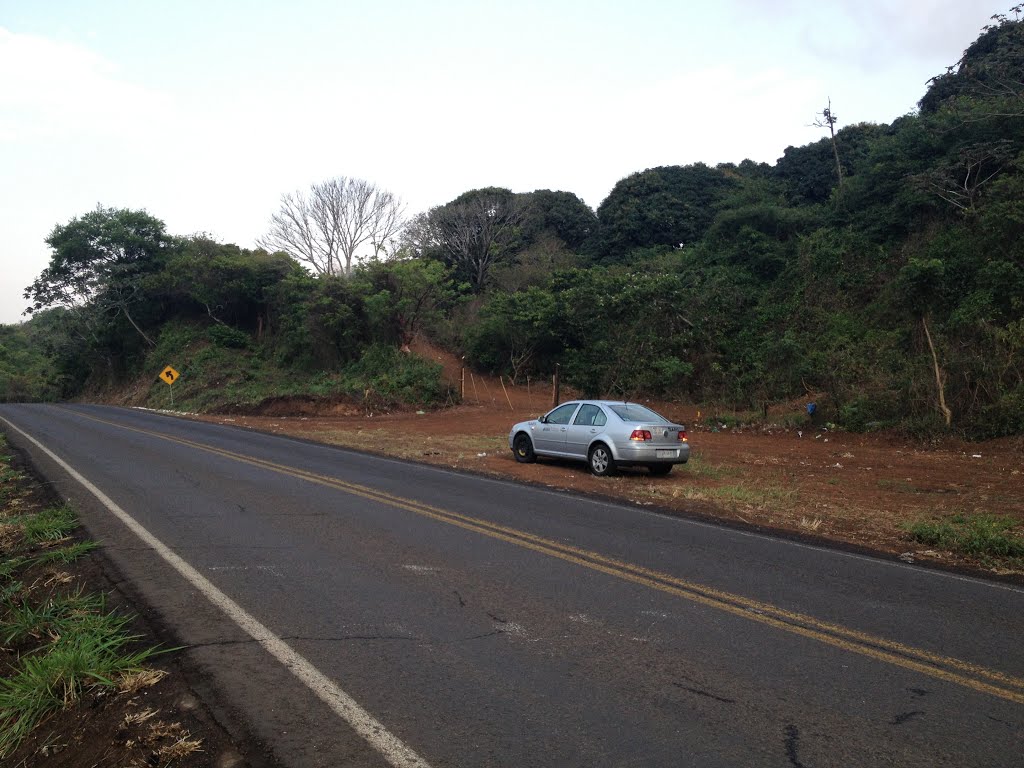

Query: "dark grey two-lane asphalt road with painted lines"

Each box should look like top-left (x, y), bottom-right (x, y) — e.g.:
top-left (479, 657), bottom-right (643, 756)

top-left (0, 406), bottom-right (1024, 768)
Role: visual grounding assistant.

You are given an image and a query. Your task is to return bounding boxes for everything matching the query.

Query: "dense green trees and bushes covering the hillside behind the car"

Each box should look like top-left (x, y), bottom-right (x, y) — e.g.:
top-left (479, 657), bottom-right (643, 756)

top-left (0, 16), bottom-right (1024, 437)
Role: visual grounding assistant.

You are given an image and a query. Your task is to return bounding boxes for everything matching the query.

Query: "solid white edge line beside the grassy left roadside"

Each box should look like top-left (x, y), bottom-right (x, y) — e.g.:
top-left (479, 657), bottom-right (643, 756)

top-left (0, 417), bottom-right (430, 768)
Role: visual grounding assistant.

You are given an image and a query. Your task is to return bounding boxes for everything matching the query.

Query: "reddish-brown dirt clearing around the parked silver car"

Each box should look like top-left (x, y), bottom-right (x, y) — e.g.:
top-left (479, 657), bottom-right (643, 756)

top-left (190, 344), bottom-right (1024, 581)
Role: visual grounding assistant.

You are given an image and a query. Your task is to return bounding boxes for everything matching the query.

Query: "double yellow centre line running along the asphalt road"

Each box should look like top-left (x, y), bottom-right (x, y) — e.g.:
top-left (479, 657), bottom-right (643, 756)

top-left (75, 412), bottom-right (1024, 705)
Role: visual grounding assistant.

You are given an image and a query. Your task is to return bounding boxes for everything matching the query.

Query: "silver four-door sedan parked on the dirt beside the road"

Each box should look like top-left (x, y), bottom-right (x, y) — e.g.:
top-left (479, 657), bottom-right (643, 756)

top-left (509, 400), bottom-right (690, 476)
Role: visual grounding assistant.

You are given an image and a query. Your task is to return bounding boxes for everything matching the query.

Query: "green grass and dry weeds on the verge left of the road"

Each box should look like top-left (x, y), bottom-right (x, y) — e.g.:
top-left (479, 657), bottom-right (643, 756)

top-left (0, 438), bottom-right (201, 766)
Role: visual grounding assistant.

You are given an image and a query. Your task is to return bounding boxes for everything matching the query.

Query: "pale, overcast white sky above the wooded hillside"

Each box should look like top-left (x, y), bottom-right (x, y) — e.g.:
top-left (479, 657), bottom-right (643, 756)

top-left (0, 0), bottom-right (1010, 323)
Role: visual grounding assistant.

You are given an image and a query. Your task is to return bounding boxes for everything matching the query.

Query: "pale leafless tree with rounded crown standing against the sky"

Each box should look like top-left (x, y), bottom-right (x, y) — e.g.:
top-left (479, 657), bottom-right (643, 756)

top-left (258, 176), bottom-right (404, 275)
